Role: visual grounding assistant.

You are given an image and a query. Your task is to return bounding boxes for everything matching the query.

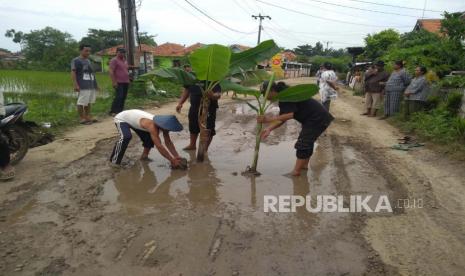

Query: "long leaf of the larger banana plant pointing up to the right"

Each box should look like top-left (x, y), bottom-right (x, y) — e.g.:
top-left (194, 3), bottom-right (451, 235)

top-left (229, 40), bottom-right (281, 75)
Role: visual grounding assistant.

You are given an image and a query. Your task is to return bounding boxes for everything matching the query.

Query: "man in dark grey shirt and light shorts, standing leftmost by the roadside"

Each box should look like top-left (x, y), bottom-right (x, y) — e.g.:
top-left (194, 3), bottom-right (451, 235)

top-left (71, 44), bottom-right (99, 125)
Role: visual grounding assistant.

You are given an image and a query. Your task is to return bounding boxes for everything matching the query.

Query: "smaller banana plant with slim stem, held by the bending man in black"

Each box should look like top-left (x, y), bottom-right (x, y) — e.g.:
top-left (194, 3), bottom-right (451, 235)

top-left (221, 73), bottom-right (318, 176)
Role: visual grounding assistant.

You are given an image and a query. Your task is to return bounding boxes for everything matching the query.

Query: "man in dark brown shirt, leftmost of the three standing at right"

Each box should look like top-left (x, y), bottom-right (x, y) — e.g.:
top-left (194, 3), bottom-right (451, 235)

top-left (362, 60), bottom-right (389, 117)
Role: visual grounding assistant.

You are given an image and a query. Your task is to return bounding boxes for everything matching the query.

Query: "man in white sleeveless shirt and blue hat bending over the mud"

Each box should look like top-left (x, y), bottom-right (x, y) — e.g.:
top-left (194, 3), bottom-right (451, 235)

top-left (110, 109), bottom-right (185, 169)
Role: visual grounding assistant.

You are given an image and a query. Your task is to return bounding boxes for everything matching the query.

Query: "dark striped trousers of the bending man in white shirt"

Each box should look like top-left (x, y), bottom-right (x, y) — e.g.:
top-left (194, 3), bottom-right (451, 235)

top-left (110, 122), bottom-right (154, 164)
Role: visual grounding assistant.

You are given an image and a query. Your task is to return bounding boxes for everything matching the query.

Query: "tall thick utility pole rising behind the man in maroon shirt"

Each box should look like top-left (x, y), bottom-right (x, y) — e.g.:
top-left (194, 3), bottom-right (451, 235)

top-left (118, 0), bottom-right (137, 77)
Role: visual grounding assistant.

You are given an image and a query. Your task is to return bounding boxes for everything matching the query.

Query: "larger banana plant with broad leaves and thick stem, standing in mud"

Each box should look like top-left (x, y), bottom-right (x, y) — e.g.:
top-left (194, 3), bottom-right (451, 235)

top-left (142, 40), bottom-right (280, 162)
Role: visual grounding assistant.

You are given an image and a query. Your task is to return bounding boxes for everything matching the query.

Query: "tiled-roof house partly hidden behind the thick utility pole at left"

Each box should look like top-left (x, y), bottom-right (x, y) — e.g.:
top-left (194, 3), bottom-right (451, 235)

top-left (95, 44), bottom-right (156, 72)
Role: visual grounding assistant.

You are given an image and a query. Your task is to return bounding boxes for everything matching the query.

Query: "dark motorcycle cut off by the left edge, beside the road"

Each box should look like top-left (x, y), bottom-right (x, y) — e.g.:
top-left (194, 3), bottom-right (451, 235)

top-left (0, 103), bottom-right (53, 165)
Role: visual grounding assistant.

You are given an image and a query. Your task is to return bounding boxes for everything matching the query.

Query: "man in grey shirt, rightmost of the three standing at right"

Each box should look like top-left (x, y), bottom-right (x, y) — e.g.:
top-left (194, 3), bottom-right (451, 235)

top-left (404, 66), bottom-right (429, 118)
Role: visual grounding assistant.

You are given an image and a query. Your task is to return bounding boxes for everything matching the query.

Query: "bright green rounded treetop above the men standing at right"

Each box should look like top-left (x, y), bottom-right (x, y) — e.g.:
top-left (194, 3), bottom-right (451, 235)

top-left (363, 29), bottom-right (400, 60)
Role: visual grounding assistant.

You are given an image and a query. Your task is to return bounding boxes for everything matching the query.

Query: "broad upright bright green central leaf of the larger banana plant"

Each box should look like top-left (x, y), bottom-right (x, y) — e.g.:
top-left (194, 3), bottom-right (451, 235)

top-left (189, 44), bottom-right (231, 82)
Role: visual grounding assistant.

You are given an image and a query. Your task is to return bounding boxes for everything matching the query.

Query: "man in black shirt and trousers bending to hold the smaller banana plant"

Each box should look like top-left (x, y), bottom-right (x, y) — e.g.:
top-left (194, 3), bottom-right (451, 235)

top-left (257, 82), bottom-right (334, 176)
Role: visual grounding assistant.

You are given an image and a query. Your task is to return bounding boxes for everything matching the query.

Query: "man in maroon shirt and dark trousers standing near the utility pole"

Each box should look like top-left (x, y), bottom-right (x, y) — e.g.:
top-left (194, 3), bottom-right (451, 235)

top-left (109, 48), bottom-right (129, 116)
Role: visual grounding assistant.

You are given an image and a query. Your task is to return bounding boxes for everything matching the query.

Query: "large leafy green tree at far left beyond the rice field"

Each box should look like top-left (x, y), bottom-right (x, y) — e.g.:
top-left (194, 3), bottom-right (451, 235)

top-left (5, 27), bottom-right (78, 71)
